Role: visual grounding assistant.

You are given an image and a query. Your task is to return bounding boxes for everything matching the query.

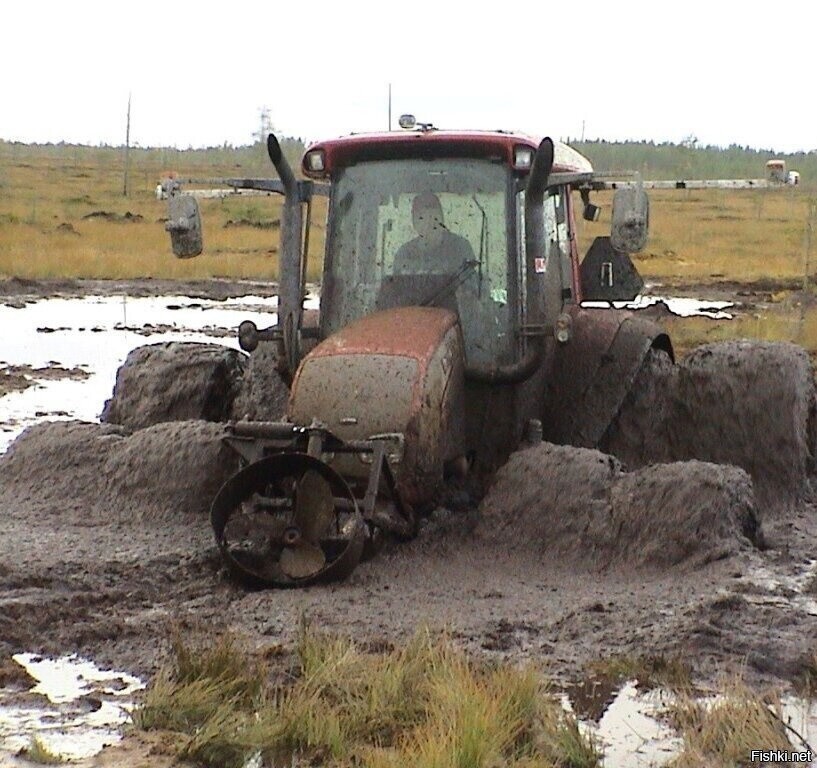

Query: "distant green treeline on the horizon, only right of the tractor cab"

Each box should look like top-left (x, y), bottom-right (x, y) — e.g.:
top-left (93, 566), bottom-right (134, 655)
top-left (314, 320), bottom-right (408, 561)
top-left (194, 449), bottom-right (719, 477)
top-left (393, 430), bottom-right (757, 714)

top-left (568, 141), bottom-right (817, 184)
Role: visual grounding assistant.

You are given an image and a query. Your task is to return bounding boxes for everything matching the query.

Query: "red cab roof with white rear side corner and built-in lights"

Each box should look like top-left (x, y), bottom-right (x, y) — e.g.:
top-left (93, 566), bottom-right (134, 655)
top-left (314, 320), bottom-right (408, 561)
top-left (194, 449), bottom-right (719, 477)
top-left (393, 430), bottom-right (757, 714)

top-left (302, 128), bottom-right (593, 178)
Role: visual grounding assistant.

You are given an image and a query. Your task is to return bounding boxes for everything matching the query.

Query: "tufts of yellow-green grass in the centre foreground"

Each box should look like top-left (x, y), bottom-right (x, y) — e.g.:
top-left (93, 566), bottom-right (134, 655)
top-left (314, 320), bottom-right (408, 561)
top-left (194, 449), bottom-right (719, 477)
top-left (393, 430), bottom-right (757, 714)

top-left (135, 629), bottom-right (599, 768)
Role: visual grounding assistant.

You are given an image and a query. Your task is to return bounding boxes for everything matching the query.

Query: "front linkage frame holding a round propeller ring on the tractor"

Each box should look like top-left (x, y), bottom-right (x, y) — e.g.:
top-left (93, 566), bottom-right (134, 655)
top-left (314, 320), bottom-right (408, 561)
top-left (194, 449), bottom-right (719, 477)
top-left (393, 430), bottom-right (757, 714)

top-left (210, 421), bottom-right (417, 587)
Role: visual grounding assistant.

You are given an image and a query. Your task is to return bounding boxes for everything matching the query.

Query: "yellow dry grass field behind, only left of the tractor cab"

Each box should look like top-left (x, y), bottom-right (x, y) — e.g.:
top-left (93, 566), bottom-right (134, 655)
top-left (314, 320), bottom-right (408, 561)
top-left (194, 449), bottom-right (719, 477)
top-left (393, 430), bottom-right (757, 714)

top-left (0, 143), bottom-right (326, 280)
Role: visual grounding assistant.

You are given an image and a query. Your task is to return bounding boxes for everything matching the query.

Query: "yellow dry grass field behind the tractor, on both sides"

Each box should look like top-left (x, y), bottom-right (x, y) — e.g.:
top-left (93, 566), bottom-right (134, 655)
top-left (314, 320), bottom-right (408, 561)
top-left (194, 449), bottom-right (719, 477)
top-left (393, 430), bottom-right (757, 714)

top-left (0, 142), bottom-right (817, 284)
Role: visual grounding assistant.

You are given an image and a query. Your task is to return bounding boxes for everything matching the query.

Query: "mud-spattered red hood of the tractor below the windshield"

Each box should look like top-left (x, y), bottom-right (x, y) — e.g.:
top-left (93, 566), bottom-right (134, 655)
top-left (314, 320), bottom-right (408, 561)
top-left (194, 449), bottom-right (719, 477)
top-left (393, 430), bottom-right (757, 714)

top-left (289, 307), bottom-right (465, 504)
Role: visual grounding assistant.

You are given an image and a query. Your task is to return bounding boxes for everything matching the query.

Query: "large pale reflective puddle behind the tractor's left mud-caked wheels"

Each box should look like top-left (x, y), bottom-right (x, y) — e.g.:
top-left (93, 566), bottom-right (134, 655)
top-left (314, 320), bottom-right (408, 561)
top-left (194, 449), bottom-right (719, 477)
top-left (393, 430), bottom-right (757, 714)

top-left (0, 296), bottom-right (318, 452)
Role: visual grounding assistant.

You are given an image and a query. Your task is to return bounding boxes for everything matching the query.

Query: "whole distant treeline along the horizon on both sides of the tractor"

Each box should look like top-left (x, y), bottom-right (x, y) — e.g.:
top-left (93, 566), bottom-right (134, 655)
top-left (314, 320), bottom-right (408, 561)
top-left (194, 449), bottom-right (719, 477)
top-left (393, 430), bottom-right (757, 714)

top-left (0, 138), bottom-right (817, 186)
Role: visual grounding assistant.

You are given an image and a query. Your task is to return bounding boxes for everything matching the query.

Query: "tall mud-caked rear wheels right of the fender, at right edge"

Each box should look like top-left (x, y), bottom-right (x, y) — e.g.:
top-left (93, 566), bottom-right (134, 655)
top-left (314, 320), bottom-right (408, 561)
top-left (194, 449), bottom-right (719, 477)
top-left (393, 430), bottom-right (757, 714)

top-left (602, 341), bottom-right (817, 511)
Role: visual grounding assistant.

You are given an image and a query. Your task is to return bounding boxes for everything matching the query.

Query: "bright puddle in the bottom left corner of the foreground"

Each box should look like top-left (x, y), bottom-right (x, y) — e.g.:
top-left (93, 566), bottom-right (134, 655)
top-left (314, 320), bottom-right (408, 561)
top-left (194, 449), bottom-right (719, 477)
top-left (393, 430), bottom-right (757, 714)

top-left (0, 653), bottom-right (145, 760)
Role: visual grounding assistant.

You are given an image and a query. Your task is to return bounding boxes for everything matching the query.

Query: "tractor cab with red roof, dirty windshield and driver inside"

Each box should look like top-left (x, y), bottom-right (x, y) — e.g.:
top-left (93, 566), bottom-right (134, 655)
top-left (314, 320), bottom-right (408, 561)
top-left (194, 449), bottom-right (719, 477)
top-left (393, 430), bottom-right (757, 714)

top-left (303, 129), bottom-right (592, 370)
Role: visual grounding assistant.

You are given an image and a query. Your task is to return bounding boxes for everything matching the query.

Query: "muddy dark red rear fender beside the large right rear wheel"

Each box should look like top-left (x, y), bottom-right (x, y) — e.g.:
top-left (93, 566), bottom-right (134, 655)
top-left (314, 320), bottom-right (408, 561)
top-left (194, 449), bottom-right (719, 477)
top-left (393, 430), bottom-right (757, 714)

top-left (542, 306), bottom-right (675, 448)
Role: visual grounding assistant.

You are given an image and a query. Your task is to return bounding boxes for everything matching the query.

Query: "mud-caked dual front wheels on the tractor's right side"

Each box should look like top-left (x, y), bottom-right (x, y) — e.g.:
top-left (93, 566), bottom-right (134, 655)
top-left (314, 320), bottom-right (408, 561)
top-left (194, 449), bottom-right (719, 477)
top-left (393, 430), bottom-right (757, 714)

top-left (480, 443), bottom-right (762, 572)
